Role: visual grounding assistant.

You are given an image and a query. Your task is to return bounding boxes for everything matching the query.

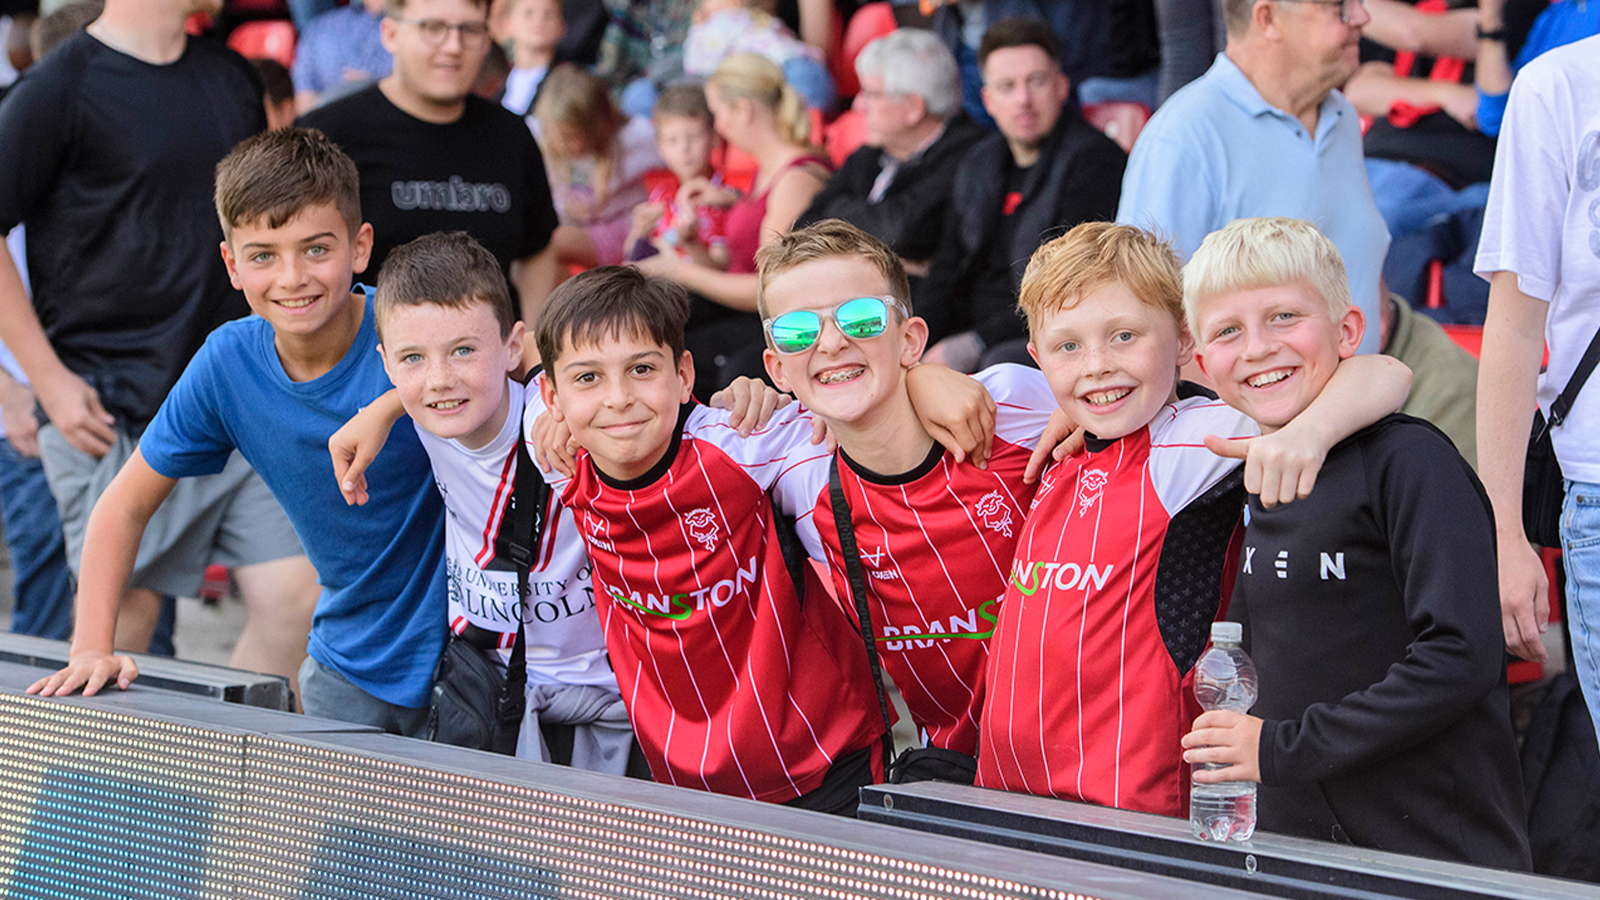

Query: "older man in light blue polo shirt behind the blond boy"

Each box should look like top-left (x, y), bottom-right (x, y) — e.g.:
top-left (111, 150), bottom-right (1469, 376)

top-left (1117, 0), bottom-right (1389, 352)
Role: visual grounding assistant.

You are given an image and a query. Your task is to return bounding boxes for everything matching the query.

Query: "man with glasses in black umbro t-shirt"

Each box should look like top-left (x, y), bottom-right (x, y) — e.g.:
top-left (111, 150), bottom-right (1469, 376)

top-left (299, 0), bottom-right (557, 352)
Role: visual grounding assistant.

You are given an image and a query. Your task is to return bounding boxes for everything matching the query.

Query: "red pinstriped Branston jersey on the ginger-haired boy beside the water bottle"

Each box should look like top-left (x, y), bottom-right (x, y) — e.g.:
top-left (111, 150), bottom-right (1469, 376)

top-left (978, 397), bottom-right (1259, 815)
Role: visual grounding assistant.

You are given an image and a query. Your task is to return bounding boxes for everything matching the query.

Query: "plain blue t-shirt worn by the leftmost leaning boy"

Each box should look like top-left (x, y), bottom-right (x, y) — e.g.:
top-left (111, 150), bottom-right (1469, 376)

top-left (139, 288), bottom-right (446, 708)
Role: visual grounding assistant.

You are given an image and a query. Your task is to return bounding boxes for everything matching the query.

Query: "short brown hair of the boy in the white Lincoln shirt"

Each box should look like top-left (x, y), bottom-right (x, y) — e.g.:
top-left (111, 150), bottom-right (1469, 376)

top-left (373, 231), bottom-right (517, 341)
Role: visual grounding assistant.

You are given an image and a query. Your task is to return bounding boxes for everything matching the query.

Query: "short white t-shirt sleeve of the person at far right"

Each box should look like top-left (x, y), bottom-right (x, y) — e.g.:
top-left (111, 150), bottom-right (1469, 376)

top-left (1472, 54), bottom-right (1573, 301)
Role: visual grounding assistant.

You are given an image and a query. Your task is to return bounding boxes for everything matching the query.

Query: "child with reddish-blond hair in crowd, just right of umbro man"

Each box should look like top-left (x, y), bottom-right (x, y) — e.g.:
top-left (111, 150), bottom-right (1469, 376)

top-left (533, 64), bottom-right (661, 266)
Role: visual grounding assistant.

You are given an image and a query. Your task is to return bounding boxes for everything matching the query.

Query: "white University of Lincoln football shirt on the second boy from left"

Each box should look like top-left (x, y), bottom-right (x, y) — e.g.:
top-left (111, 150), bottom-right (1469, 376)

top-left (416, 381), bottom-right (616, 689)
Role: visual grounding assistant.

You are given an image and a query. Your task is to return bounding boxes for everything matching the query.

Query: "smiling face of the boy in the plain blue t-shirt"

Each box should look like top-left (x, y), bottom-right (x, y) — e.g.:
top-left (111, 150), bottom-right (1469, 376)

top-left (222, 203), bottom-right (373, 343)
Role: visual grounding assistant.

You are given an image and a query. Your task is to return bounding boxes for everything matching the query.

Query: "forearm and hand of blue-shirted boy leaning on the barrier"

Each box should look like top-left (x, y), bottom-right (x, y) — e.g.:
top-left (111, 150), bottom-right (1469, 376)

top-left (27, 450), bottom-right (178, 697)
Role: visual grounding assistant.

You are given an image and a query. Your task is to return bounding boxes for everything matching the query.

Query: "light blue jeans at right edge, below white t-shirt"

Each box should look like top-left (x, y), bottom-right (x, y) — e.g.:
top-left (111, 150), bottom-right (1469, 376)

top-left (1562, 480), bottom-right (1600, 733)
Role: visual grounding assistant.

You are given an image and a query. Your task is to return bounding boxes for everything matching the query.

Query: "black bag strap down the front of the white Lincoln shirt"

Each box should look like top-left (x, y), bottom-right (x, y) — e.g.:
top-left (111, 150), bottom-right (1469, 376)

top-left (494, 370), bottom-right (550, 754)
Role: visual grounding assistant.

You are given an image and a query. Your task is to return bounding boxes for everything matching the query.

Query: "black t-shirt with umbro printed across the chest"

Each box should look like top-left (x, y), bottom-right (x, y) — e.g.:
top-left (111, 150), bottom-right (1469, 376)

top-left (299, 85), bottom-right (555, 280)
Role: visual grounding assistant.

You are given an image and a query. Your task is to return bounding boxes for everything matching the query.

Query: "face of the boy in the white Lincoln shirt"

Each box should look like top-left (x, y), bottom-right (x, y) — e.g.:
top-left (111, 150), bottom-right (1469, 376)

top-left (378, 303), bottom-right (522, 450)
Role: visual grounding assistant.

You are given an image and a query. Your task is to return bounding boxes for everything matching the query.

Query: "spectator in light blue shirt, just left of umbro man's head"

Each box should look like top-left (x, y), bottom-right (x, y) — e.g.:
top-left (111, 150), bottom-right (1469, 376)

top-left (291, 0), bottom-right (394, 114)
